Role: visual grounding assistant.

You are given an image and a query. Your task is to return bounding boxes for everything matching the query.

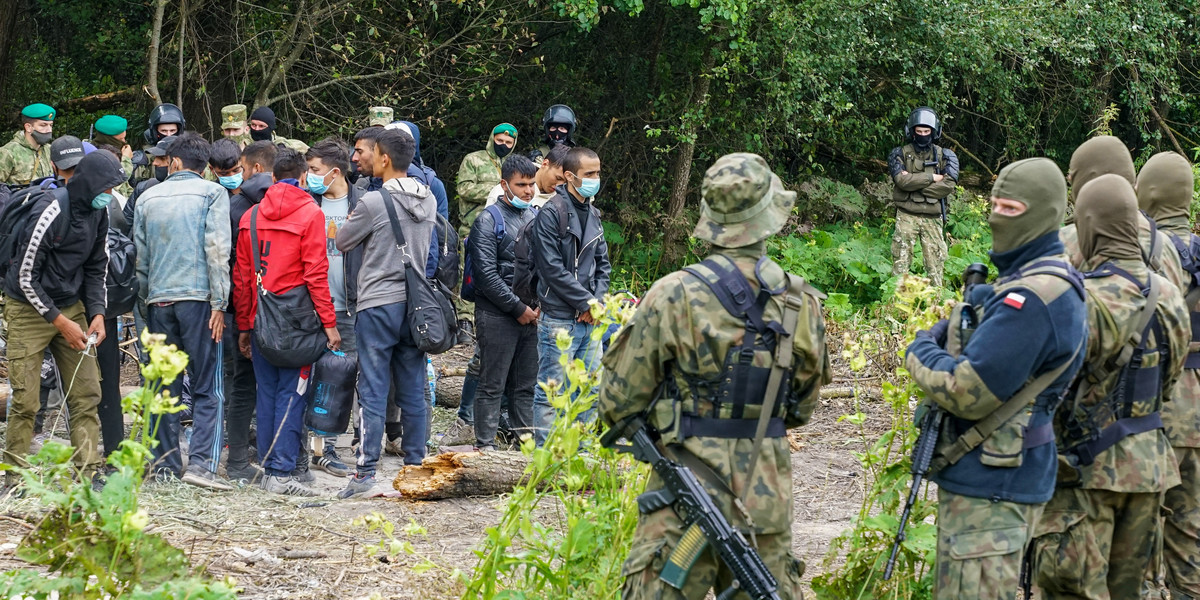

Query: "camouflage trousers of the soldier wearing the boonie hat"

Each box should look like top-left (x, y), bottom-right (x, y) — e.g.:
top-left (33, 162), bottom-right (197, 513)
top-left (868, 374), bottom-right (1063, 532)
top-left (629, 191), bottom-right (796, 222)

top-left (620, 508), bottom-right (804, 600)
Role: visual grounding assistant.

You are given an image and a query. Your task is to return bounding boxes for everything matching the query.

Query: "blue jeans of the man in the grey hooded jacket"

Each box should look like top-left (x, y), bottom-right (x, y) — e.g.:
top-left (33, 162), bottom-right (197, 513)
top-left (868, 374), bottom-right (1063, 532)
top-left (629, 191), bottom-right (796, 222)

top-left (354, 302), bottom-right (430, 476)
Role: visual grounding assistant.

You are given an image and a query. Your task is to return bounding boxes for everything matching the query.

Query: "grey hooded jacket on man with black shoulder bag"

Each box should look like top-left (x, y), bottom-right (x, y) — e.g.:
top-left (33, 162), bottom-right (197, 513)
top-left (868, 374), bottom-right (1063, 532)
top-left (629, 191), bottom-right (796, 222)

top-left (333, 178), bottom-right (438, 312)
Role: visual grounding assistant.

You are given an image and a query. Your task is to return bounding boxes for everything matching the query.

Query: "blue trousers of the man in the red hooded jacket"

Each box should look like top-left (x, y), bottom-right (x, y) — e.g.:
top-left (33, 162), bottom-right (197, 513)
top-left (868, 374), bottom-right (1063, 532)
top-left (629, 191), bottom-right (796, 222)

top-left (251, 340), bottom-right (312, 478)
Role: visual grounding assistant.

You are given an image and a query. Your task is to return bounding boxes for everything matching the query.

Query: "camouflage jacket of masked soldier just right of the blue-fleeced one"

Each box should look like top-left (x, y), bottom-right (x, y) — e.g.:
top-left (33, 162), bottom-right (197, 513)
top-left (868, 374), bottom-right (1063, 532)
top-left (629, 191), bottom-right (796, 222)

top-left (1055, 257), bottom-right (1192, 493)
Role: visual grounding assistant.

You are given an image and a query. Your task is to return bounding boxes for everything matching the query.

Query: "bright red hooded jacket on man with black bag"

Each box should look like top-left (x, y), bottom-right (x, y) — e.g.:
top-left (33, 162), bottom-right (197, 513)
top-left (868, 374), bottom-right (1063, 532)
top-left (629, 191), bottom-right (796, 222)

top-left (234, 182), bottom-right (337, 332)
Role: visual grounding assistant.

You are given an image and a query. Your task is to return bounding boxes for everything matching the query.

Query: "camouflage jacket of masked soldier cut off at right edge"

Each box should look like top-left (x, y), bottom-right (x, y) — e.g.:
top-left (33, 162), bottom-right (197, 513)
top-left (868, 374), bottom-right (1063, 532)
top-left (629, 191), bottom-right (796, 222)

top-left (1158, 217), bottom-right (1200, 448)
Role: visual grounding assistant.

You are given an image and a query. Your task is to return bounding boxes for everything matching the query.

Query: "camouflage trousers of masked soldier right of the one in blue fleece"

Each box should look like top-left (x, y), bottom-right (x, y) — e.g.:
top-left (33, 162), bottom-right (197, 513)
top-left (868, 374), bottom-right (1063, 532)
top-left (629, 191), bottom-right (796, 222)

top-left (1033, 488), bottom-right (1162, 600)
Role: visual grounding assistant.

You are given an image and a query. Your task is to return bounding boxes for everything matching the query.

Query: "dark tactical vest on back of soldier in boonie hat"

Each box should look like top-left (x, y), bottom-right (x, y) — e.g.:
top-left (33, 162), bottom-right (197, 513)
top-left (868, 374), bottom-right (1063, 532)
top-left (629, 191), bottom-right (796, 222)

top-left (662, 256), bottom-right (816, 440)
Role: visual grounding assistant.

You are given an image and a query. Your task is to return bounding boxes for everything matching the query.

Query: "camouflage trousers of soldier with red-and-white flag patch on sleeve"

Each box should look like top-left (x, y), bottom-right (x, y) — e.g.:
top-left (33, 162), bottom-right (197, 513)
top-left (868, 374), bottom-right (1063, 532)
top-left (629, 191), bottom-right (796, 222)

top-left (934, 490), bottom-right (1044, 600)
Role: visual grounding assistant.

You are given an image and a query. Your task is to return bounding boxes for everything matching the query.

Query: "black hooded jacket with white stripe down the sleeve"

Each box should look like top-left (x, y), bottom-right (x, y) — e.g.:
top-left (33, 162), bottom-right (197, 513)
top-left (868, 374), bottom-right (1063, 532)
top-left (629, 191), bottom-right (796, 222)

top-left (4, 152), bottom-right (125, 322)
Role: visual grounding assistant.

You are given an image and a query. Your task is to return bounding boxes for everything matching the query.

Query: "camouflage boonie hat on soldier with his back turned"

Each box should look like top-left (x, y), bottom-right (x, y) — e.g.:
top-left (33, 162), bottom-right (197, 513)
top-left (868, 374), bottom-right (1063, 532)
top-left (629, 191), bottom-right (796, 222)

top-left (691, 152), bottom-right (796, 248)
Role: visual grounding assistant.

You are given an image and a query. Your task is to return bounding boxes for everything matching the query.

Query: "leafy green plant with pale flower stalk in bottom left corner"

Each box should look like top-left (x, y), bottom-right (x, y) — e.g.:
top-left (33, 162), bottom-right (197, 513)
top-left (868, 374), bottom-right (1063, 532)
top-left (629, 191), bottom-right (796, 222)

top-left (0, 335), bottom-right (236, 600)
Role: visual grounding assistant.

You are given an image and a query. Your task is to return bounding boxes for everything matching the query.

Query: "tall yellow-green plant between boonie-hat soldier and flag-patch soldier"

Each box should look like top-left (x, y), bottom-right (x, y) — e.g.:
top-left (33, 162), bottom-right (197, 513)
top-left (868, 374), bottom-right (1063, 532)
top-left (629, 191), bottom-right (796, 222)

top-left (812, 277), bottom-right (950, 600)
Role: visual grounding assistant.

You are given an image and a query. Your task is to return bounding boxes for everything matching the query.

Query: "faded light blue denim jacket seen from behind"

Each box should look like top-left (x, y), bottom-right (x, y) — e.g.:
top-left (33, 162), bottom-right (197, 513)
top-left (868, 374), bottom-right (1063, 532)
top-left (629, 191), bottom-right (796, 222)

top-left (133, 169), bottom-right (233, 311)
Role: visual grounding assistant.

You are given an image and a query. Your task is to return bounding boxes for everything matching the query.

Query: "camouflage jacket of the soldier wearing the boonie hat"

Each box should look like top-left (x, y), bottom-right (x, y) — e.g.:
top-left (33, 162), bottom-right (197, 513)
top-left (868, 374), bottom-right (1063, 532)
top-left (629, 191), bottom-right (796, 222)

top-left (600, 246), bottom-right (832, 534)
